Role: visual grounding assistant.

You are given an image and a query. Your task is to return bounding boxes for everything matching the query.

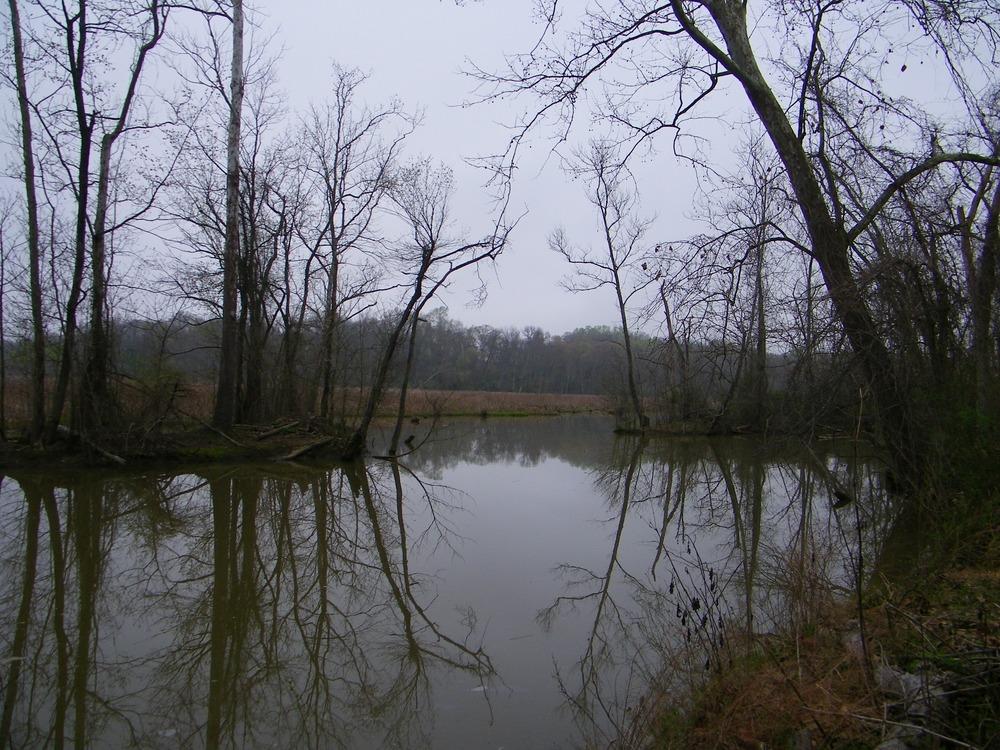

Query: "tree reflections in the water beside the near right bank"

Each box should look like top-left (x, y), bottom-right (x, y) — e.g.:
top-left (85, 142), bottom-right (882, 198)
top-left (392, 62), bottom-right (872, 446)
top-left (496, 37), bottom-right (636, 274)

top-left (539, 438), bottom-right (893, 747)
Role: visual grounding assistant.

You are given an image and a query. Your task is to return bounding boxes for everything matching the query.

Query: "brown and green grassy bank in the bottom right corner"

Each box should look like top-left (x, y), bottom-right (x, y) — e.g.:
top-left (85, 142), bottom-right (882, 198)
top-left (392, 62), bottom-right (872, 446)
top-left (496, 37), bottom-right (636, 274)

top-left (622, 495), bottom-right (1000, 750)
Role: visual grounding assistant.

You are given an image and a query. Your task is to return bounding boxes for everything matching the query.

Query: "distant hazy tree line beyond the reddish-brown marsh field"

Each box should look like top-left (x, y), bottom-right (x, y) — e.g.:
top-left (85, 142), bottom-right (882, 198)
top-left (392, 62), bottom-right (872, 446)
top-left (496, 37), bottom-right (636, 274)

top-left (5, 308), bottom-right (656, 402)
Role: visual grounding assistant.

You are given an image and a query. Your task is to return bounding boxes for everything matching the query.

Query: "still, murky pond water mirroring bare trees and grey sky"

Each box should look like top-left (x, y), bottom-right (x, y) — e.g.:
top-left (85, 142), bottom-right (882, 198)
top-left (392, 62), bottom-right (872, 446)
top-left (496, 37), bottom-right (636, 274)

top-left (0, 417), bottom-right (892, 748)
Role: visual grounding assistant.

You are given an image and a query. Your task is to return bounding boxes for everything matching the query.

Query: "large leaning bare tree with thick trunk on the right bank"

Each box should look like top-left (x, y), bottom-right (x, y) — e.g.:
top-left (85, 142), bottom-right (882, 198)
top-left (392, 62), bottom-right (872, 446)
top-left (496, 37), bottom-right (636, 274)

top-left (478, 0), bottom-right (995, 481)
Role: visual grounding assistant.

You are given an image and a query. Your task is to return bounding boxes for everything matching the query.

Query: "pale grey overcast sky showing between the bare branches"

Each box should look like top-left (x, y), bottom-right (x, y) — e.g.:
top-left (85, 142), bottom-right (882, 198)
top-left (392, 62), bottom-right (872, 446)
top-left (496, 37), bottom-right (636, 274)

top-left (1, 0), bottom-right (957, 333)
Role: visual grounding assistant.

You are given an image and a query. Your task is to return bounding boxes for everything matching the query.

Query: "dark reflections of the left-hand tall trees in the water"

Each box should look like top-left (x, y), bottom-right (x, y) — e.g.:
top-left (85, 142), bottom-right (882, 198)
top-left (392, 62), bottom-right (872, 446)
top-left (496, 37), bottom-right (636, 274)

top-left (0, 463), bottom-right (494, 748)
